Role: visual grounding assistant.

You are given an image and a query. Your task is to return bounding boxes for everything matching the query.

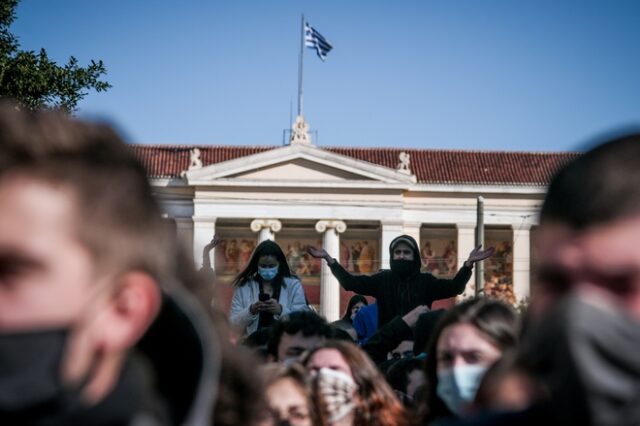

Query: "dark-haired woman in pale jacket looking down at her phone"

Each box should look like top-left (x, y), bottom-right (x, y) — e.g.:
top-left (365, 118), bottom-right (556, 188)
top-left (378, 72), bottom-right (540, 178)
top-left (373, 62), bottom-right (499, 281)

top-left (230, 240), bottom-right (308, 335)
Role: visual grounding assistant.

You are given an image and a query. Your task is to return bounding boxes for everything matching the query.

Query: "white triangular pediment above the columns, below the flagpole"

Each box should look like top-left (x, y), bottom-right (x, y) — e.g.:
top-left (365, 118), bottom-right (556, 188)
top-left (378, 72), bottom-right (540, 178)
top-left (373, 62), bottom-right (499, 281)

top-left (185, 145), bottom-right (415, 185)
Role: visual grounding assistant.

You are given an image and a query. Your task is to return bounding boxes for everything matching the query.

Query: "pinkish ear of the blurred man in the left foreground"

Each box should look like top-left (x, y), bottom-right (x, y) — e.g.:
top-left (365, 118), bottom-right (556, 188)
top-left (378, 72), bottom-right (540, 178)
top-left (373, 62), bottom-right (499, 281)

top-left (101, 272), bottom-right (162, 352)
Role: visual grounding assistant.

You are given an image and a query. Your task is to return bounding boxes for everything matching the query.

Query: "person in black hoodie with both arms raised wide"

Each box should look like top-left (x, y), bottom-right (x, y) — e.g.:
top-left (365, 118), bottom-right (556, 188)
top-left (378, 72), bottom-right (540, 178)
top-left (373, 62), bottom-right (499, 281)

top-left (308, 235), bottom-right (494, 327)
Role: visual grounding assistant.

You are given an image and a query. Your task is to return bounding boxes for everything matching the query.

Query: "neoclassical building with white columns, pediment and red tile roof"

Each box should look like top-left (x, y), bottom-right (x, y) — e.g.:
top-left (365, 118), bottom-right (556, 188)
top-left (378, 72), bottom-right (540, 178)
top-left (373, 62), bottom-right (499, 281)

top-left (132, 125), bottom-right (578, 320)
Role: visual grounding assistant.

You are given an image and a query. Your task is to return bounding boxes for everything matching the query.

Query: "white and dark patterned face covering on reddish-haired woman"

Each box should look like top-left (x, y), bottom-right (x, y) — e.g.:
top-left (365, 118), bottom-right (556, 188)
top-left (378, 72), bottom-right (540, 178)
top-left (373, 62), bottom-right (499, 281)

top-left (315, 368), bottom-right (358, 423)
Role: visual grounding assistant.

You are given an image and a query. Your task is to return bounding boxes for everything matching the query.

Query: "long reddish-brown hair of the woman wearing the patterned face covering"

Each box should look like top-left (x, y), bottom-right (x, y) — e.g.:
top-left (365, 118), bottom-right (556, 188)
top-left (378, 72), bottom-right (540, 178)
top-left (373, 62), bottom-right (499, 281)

top-left (304, 340), bottom-right (409, 426)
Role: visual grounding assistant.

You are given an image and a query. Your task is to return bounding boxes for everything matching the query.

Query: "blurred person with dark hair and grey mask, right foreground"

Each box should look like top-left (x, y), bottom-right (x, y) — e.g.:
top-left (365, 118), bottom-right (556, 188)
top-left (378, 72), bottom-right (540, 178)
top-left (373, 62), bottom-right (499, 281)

top-left (523, 134), bottom-right (640, 424)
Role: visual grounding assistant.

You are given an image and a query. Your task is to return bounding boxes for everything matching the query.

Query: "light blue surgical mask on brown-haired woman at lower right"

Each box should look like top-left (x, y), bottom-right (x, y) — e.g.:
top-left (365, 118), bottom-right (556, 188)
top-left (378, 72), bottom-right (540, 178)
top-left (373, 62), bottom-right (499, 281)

top-left (436, 365), bottom-right (487, 417)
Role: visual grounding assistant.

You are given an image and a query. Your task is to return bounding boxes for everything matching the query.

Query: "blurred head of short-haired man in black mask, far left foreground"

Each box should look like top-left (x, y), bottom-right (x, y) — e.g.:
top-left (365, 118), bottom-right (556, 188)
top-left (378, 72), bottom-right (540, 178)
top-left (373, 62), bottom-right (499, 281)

top-left (0, 103), bottom-right (216, 424)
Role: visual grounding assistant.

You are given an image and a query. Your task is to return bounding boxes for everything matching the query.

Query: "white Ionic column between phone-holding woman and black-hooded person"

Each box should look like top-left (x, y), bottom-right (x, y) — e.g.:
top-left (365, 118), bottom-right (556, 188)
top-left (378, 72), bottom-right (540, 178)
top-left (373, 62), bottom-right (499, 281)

top-left (316, 220), bottom-right (347, 322)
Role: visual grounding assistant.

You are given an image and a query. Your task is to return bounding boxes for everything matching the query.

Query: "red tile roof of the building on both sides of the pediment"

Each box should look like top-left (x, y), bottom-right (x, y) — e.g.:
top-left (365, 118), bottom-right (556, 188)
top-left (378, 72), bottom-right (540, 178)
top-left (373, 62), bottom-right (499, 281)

top-left (131, 145), bottom-right (580, 186)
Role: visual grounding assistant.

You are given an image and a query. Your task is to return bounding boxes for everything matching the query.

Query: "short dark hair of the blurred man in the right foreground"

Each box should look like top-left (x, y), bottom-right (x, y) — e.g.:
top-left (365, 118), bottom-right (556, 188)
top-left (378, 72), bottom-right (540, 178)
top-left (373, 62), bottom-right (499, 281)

top-left (540, 134), bottom-right (640, 229)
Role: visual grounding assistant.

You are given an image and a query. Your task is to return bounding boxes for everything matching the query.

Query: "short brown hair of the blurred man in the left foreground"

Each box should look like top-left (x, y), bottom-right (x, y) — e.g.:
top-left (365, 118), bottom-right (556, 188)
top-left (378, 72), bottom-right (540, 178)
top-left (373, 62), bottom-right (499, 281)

top-left (0, 102), bottom-right (175, 283)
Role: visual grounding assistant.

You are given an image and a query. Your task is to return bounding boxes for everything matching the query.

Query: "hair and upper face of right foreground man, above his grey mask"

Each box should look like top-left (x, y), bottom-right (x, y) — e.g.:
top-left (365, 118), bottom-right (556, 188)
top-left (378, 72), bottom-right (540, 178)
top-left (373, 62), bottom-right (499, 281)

top-left (533, 134), bottom-right (640, 318)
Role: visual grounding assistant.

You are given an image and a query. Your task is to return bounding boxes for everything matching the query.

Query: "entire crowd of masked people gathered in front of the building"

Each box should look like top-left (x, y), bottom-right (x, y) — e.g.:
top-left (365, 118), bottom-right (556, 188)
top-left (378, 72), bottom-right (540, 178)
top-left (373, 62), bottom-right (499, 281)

top-left (0, 103), bottom-right (640, 426)
